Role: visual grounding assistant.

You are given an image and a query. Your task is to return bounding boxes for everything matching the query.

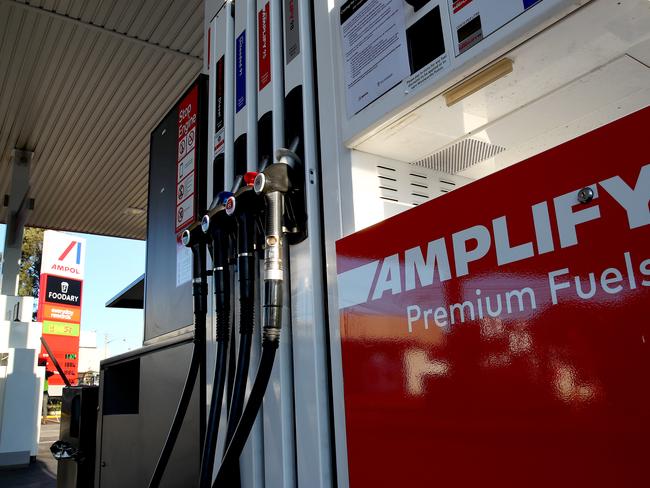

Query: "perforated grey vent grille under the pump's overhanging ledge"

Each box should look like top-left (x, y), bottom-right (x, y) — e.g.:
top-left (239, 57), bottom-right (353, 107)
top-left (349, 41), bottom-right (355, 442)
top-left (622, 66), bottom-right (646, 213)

top-left (412, 139), bottom-right (506, 174)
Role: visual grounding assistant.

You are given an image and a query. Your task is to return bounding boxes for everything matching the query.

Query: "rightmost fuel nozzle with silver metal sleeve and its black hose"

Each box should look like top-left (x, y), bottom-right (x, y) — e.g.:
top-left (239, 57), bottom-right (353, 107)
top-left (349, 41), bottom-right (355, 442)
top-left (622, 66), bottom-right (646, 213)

top-left (213, 138), bottom-right (304, 487)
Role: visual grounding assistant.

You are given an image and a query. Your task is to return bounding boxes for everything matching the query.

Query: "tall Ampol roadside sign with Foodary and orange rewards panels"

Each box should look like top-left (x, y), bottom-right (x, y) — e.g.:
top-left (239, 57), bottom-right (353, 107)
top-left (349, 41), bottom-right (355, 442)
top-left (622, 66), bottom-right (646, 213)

top-left (38, 230), bottom-right (86, 396)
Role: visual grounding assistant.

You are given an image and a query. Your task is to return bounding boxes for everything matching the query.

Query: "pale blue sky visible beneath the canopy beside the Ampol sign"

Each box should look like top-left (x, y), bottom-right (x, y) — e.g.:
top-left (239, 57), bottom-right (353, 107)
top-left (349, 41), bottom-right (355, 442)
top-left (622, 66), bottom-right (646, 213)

top-left (0, 225), bottom-right (146, 357)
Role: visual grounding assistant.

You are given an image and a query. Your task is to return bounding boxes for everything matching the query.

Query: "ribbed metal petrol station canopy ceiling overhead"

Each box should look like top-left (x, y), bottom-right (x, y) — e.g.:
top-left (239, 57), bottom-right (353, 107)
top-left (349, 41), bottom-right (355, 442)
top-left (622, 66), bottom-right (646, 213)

top-left (0, 0), bottom-right (203, 239)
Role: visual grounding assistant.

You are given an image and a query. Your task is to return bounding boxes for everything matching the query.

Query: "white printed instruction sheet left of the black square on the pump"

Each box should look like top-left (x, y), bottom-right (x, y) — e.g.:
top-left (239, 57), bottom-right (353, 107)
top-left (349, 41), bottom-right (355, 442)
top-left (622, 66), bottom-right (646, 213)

top-left (340, 0), bottom-right (410, 116)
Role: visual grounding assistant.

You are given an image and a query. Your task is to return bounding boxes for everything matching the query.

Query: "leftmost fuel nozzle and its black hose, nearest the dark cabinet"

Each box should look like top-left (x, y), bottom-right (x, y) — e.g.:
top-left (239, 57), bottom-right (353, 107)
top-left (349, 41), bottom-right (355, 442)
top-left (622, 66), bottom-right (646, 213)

top-left (149, 222), bottom-right (208, 488)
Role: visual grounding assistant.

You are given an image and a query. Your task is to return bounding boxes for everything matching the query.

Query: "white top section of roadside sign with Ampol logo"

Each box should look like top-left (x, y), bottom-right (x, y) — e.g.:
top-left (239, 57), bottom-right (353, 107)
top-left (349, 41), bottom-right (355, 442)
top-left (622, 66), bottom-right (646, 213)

top-left (41, 230), bottom-right (86, 279)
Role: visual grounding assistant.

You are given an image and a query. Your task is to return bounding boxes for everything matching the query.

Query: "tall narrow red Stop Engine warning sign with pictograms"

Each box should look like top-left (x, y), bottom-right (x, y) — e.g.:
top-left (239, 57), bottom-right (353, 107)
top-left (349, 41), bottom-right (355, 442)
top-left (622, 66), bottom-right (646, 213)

top-left (175, 86), bottom-right (198, 232)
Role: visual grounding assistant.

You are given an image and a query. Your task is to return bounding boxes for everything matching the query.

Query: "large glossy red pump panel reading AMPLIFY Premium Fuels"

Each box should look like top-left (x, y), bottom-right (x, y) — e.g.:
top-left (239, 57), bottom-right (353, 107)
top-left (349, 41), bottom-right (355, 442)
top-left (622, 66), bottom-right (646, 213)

top-left (337, 108), bottom-right (650, 487)
